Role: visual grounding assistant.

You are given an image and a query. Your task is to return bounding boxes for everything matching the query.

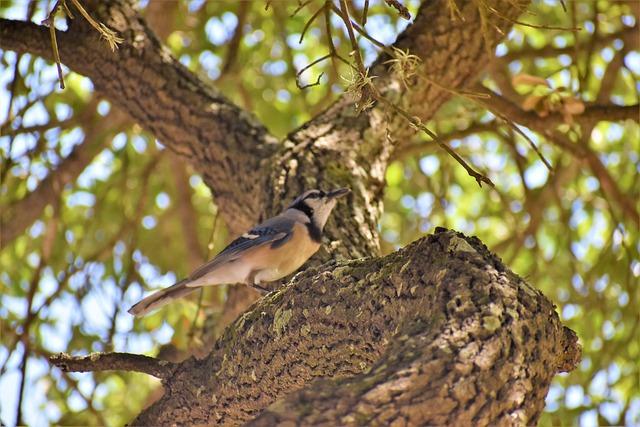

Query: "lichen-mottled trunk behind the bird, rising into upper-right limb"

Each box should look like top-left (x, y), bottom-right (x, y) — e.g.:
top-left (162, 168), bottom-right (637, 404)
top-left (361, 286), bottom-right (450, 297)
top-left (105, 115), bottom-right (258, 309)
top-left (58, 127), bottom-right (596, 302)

top-left (258, 0), bottom-right (527, 259)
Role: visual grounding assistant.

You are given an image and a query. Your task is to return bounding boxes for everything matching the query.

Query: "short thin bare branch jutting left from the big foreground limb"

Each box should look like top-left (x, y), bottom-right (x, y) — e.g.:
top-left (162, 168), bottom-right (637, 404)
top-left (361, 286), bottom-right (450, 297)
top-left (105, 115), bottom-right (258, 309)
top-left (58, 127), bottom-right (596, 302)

top-left (49, 353), bottom-right (178, 379)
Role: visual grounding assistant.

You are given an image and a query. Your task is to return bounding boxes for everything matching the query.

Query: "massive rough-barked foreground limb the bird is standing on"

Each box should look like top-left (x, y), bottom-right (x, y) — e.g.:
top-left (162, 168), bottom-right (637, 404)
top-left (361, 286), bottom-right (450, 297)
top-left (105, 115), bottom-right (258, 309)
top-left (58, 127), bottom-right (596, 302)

top-left (134, 229), bottom-right (580, 425)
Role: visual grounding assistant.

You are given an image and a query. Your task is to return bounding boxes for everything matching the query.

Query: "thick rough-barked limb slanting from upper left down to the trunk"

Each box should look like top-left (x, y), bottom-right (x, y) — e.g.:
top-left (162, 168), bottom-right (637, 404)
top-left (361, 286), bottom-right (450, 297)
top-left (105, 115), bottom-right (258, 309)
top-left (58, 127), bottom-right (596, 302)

top-left (0, 8), bottom-right (277, 233)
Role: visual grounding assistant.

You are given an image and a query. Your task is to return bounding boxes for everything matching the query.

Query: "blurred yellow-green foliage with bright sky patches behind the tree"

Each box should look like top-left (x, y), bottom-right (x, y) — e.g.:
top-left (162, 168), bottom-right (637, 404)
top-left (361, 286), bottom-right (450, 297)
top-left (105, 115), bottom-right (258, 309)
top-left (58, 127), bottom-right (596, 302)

top-left (0, 0), bottom-right (640, 425)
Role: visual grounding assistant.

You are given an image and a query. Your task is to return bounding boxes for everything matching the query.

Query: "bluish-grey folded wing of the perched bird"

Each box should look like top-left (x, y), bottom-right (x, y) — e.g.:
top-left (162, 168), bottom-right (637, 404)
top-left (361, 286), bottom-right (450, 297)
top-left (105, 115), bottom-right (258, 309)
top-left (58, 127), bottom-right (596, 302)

top-left (188, 215), bottom-right (294, 282)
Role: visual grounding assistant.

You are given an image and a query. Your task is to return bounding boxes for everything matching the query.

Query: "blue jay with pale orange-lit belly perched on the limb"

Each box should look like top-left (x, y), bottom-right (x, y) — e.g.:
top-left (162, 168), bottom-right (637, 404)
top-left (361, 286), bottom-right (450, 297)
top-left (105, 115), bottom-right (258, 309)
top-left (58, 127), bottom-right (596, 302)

top-left (129, 188), bottom-right (351, 316)
